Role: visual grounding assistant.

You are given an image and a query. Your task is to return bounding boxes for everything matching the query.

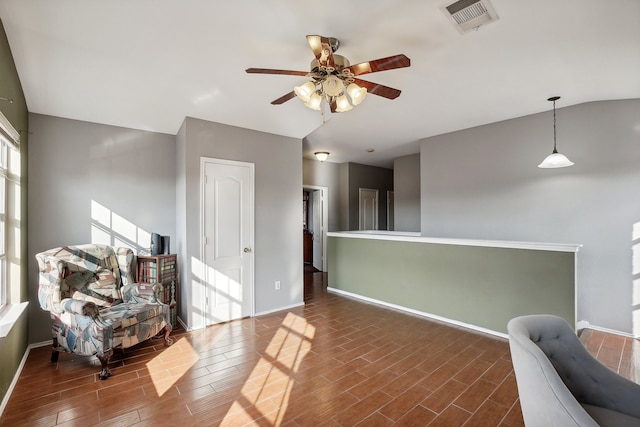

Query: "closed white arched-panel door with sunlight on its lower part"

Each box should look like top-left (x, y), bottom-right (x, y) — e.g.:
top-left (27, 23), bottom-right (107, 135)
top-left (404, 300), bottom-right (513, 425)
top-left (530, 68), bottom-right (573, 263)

top-left (201, 159), bottom-right (254, 325)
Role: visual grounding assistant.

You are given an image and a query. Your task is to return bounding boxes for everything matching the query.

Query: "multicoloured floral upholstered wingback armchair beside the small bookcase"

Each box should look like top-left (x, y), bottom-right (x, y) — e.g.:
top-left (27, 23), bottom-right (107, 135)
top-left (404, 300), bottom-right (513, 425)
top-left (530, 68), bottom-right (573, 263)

top-left (36, 244), bottom-right (172, 380)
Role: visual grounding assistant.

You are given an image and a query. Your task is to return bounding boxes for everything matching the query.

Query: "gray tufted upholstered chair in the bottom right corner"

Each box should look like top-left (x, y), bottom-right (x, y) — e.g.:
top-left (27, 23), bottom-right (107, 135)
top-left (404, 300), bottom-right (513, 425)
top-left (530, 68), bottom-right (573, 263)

top-left (507, 315), bottom-right (640, 425)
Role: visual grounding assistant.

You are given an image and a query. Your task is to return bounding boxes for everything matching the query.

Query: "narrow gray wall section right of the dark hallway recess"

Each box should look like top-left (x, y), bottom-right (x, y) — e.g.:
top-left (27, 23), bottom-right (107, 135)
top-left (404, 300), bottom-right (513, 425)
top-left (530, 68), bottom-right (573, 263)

top-left (393, 154), bottom-right (420, 231)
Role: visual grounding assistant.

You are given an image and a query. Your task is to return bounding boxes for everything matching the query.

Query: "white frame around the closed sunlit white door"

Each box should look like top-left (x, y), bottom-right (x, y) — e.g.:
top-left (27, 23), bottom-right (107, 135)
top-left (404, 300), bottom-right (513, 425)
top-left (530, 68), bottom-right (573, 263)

top-left (199, 157), bottom-right (256, 327)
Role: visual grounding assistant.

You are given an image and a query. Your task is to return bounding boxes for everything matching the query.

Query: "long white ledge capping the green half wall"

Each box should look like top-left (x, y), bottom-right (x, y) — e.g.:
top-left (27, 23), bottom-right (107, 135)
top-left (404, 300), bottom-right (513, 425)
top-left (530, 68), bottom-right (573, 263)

top-left (327, 231), bottom-right (582, 252)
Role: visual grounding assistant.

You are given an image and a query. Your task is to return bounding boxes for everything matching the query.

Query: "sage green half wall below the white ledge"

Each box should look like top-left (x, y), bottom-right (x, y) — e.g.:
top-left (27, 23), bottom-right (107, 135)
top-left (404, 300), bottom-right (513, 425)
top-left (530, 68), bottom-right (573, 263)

top-left (328, 237), bottom-right (576, 333)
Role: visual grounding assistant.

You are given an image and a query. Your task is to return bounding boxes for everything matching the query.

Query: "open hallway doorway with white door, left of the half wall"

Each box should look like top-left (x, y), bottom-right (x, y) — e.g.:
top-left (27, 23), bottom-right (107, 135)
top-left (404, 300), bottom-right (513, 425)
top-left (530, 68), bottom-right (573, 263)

top-left (302, 185), bottom-right (329, 271)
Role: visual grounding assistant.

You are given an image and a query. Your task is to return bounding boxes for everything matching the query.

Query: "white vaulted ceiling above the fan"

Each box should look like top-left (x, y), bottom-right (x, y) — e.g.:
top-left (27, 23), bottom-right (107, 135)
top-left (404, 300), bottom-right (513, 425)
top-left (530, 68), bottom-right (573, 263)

top-left (0, 0), bottom-right (640, 166)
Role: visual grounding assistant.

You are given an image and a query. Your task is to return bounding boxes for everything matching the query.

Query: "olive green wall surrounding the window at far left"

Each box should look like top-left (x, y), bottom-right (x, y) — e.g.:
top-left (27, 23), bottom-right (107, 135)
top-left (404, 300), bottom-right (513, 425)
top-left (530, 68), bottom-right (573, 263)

top-left (0, 17), bottom-right (29, 408)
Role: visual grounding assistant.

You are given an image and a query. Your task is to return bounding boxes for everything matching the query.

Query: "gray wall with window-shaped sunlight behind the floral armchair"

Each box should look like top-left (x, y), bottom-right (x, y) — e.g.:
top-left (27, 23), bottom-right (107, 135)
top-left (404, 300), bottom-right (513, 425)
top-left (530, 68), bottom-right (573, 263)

top-left (28, 114), bottom-right (176, 343)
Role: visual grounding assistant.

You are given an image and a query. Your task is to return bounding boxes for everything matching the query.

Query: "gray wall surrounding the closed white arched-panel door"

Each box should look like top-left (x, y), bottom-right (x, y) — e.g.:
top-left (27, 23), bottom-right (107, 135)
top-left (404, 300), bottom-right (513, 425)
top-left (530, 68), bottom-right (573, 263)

top-left (176, 118), bottom-right (304, 327)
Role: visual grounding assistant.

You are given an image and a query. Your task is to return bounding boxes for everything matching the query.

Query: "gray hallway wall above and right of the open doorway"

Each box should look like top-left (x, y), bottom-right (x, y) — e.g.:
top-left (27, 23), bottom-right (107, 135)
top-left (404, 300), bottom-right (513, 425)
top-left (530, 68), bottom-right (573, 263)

top-left (302, 159), bottom-right (340, 231)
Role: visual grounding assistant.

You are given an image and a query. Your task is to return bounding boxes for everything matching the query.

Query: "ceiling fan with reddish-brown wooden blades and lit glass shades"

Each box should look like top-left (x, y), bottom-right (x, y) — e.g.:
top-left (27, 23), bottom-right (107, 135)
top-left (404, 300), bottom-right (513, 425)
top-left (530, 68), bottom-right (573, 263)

top-left (246, 35), bottom-right (411, 113)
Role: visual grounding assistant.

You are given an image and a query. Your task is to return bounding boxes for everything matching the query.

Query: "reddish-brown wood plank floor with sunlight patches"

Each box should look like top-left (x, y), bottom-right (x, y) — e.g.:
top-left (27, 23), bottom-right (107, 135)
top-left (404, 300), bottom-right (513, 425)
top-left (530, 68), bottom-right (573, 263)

top-left (0, 273), bottom-right (640, 426)
